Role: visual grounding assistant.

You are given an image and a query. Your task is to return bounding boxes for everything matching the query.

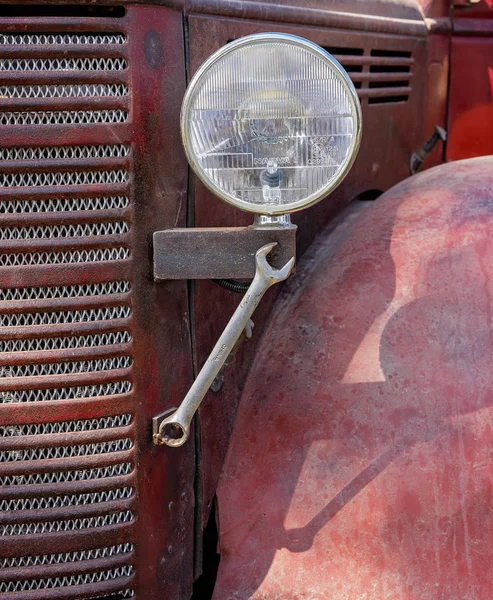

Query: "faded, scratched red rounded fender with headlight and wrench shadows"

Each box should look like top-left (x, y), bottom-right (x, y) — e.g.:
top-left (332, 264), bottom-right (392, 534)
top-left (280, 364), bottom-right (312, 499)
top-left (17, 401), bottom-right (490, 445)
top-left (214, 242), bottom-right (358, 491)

top-left (214, 157), bottom-right (493, 600)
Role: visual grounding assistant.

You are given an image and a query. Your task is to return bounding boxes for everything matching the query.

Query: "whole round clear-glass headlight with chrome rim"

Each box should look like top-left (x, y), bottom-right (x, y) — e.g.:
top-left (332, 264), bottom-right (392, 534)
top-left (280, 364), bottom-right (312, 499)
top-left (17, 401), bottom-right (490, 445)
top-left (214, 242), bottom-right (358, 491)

top-left (181, 33), bottom-right (361, 215)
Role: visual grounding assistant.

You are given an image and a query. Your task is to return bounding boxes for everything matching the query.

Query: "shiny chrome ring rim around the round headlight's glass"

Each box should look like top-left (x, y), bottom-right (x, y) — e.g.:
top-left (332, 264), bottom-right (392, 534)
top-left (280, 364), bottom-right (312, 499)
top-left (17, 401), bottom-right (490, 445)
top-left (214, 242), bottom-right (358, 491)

top-left (180, 32), bottom-right (362, 215)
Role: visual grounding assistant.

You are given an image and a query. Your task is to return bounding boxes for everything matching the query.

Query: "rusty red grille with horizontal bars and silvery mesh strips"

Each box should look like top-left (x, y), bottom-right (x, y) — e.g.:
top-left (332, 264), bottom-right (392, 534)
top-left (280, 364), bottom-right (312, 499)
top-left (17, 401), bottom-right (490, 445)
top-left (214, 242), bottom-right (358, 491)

top-left (0, 10), bottom-right (137, 600)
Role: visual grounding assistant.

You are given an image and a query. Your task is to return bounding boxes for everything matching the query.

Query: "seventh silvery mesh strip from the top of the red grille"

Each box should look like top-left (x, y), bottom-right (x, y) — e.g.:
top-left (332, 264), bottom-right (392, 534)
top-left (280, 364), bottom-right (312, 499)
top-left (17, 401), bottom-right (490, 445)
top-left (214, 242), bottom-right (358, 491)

top-left (0, 196), bottom-right (129, 213)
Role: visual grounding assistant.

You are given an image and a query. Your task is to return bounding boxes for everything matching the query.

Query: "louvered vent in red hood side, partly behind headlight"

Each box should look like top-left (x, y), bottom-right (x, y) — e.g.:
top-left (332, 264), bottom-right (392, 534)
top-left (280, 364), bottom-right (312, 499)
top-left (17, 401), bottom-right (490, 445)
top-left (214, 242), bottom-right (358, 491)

top-left (326, 47), bottom-right (414, 105)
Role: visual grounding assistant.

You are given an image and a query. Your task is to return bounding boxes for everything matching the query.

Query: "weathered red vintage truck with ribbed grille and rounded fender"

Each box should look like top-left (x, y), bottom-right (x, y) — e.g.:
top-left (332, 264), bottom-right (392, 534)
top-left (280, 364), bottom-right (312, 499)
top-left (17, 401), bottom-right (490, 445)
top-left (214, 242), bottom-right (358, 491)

top-left (0, 0), bottom-right (493, 600)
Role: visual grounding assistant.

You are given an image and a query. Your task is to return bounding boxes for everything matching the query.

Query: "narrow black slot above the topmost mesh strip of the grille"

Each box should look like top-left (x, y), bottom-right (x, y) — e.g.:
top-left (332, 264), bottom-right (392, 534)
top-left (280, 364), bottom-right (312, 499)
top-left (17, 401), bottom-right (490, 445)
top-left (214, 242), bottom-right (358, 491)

top-left (0, 4), bottom-right (125, 19)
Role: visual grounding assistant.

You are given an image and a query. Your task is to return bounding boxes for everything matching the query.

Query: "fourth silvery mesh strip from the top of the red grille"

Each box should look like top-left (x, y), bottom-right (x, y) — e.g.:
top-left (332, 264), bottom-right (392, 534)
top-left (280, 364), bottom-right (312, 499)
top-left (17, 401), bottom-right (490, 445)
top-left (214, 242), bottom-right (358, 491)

top-left (0, 110), bottom-right (128, 125)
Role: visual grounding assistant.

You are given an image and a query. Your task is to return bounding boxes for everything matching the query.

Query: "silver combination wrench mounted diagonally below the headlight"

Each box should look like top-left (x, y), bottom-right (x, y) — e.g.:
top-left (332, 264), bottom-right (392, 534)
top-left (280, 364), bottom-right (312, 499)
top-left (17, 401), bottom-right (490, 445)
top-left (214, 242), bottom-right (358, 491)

top-left (157, 242), bottom-right (294, 447)
